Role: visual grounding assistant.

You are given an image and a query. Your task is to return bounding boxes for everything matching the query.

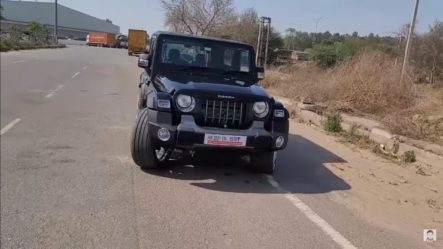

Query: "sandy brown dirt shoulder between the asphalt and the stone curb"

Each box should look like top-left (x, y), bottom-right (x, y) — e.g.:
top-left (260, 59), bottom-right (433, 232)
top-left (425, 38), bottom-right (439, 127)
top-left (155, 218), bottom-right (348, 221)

top-left (290, 120), bottom-right (443, 245)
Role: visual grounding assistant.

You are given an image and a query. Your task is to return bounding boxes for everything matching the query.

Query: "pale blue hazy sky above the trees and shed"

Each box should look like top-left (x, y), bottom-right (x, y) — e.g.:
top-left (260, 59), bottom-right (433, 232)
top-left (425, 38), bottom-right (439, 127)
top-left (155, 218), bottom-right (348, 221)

top-left (52, 0), bottom-right (443, 35)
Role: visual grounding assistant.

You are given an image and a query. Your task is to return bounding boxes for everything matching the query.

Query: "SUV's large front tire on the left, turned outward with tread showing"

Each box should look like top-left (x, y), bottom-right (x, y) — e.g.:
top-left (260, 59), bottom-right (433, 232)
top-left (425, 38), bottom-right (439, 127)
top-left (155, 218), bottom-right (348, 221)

top-left (131, 109), bottom-right (171, 170)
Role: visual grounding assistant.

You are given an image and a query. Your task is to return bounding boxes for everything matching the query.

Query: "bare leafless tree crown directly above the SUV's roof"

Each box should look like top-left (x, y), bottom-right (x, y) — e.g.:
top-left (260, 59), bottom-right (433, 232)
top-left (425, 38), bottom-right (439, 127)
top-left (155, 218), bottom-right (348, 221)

top-left (162, 0), bottom-right (234, 35)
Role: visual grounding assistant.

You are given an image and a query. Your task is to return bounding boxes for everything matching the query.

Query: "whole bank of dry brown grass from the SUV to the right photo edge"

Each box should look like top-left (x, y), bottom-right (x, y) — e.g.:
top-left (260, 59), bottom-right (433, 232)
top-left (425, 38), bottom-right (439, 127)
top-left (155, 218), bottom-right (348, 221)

top-left (263, 52), bottom-right (443, 143)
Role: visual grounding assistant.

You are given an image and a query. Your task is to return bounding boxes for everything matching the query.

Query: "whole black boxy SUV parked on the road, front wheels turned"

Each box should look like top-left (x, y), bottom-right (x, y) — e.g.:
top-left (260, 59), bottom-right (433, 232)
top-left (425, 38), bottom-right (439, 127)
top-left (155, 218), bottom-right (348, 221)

top-left (131, 32), bottom-right (289, 174)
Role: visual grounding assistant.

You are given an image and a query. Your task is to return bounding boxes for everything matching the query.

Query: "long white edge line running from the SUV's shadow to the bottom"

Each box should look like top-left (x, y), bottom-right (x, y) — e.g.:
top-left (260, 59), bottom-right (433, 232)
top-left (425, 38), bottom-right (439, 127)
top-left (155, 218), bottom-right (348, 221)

top-left (265, 175), bottom-right (357, 249)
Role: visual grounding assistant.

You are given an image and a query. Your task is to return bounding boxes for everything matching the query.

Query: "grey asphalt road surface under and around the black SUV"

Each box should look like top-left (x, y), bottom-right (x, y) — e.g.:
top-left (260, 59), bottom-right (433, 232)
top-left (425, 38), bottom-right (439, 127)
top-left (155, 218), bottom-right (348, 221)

top-left (1, 46), bottom-right (426, 249)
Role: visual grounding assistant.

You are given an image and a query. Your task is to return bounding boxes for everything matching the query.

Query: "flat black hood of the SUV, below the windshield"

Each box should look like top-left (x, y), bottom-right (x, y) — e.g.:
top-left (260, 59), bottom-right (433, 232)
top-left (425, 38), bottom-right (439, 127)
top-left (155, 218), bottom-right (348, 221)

top-left (154, 75), bottom-right (270, 100)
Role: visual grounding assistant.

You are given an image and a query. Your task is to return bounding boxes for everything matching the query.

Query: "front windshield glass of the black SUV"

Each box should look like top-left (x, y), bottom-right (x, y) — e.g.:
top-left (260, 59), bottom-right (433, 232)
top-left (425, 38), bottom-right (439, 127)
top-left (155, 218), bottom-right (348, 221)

top-left (160, 38), bottom-right (252, 73)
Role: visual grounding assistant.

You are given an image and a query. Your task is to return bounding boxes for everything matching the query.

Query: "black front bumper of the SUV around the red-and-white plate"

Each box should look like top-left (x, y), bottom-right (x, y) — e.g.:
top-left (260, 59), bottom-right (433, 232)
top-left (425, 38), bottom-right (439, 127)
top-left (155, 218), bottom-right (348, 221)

top-left (148, 115), bottom-right (288, 151)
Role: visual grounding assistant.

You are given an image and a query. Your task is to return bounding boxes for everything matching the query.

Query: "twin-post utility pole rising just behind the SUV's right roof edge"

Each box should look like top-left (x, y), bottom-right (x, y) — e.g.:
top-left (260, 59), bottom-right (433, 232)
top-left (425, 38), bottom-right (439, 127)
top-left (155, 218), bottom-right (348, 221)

top-left (255, 16), bottom-right (271, 67)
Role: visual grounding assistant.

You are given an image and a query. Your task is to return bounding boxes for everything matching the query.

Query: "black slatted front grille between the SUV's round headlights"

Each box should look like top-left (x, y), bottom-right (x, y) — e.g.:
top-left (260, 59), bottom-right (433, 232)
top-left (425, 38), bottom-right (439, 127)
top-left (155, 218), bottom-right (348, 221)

top-left (201, 100), bottom-right (246, 129)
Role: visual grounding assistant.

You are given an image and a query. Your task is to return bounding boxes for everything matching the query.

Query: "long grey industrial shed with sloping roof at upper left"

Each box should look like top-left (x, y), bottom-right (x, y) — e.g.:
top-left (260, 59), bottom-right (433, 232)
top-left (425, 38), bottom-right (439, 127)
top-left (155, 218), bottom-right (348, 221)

top-left (0, 0), bottom-right (120, 38)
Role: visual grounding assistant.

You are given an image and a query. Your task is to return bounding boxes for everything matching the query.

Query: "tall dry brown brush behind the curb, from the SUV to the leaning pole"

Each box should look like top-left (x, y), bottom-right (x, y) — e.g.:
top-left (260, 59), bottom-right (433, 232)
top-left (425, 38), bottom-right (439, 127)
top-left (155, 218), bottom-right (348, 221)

top-left (263, 51), bottom-right (416, 116)
